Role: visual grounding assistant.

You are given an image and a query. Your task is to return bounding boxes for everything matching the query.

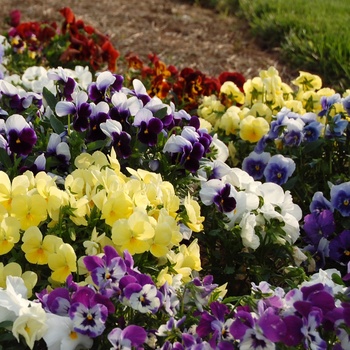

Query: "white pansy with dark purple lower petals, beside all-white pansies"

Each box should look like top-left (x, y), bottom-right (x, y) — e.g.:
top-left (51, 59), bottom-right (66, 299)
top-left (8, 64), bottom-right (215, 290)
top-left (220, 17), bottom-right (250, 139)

top-left (199, 179), bottom-right (237, 213)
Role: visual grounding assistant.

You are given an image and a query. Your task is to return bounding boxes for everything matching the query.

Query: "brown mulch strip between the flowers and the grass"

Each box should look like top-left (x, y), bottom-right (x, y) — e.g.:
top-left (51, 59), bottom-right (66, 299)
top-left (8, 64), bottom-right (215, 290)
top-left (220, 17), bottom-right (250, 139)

top-left (0, 0), bottom-right (296, 83)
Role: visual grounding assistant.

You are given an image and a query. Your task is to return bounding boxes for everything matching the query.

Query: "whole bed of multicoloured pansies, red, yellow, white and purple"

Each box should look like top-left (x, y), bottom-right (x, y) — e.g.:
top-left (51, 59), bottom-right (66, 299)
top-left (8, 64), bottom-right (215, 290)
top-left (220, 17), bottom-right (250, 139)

top-left (0, 8), bottom-right (350, 350)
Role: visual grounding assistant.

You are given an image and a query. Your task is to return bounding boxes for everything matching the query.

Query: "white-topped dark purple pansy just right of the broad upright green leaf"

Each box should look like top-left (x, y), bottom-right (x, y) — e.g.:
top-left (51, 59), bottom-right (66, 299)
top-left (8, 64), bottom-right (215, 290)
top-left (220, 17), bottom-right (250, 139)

top-left (55, 91), bottom-right (92, 131)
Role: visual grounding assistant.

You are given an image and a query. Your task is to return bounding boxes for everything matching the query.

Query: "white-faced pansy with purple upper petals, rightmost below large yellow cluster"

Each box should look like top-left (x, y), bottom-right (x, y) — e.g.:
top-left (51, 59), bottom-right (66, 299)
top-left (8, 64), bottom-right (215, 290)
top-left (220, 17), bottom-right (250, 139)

top-left (123, 283), bottom-right (162, 313)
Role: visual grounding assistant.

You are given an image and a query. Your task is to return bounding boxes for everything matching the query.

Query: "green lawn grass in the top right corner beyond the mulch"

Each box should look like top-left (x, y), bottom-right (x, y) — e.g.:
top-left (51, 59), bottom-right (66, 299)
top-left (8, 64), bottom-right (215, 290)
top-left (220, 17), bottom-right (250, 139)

top-left (185, 0), bottom-right (350, 91)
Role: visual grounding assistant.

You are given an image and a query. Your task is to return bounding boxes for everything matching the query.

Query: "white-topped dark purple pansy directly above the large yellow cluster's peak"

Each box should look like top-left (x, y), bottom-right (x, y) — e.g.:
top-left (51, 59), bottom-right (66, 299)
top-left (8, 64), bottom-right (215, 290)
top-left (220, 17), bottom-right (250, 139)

top-left (100, 119), bottom-right (132, 159)
